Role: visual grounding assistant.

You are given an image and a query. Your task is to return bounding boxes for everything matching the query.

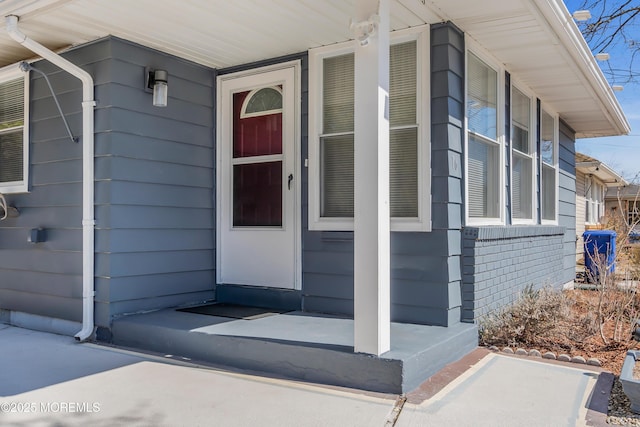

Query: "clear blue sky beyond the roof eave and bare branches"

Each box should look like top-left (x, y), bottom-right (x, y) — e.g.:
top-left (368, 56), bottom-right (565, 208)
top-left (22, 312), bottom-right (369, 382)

top-left (565, 0), bottom-right (640, 183)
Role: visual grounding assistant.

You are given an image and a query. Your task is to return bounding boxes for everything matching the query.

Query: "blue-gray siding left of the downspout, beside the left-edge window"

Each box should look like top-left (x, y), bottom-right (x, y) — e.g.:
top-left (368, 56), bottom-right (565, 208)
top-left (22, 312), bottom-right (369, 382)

top-left (0, 43), bottom-right (108, 322)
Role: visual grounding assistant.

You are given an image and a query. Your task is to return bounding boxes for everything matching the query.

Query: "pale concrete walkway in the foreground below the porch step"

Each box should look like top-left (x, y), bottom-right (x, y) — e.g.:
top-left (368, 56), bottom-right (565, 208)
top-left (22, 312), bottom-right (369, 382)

top-left (0, 324), bottom-right (598, 427)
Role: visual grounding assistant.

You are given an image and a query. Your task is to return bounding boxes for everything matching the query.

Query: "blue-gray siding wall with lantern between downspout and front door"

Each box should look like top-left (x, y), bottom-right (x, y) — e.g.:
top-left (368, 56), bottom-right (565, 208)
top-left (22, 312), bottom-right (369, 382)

top-left (95, 38), bottom-right (216, 327)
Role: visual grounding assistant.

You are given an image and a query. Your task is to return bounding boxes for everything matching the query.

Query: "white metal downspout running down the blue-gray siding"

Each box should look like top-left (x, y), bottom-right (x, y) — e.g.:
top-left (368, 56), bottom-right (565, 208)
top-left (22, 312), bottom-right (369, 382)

top-left (5, 15), bottom-right (96, 341)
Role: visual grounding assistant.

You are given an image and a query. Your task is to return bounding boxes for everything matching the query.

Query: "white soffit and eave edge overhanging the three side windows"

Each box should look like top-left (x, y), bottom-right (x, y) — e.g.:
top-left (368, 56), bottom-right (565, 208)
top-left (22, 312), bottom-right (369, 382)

top-left (431, 0), bottom-right (629, 138)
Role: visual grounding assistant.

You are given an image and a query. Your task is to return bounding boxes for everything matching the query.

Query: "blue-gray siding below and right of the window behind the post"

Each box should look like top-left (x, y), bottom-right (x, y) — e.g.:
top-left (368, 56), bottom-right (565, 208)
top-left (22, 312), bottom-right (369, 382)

top-left (303, 24), bottom-right (464, 325)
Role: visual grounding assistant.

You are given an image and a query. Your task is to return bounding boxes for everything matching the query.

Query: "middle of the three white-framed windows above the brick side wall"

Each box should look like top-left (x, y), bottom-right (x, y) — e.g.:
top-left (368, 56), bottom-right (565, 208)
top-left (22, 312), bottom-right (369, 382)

top-left (511, 87), bottom-right (534, 222)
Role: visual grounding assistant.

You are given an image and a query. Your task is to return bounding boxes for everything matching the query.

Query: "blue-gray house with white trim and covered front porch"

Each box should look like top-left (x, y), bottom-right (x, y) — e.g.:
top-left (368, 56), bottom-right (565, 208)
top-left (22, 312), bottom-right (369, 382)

top-left (0, 0), bottom-right (629, 391)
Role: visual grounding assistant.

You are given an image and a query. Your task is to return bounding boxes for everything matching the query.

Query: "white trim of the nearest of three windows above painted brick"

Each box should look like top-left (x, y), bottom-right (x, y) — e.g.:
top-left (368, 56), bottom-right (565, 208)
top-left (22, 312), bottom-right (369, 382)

top-left (463, 40), bottom-right (506, 225)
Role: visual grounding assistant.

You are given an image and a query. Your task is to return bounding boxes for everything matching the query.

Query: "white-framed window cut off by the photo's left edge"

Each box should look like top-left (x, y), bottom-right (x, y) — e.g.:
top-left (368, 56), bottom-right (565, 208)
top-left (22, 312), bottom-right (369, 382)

top-left (0, 67), bottom-right (28, 193)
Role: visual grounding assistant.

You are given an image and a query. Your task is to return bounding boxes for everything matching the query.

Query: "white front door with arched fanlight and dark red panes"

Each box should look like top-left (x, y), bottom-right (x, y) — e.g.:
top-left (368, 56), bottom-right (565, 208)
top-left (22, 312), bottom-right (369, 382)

top-left (216, 64), bottom-right (300, 289)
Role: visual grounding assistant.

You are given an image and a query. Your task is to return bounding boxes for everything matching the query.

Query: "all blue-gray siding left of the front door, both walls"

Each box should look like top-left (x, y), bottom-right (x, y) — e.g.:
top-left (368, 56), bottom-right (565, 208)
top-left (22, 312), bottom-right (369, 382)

top-left (0, 38), bottom-right (215, 327)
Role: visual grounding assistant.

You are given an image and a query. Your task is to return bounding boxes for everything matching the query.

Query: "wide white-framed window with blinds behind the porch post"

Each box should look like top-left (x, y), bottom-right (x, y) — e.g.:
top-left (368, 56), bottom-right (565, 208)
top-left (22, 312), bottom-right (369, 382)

top-left (309, 29), bottom-right (429, 231)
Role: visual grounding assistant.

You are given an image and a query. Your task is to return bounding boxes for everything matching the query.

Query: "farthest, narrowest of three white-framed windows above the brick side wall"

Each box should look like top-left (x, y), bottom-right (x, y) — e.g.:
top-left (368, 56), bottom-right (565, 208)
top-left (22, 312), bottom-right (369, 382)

top-left (540, 109), bottom-right (558, 221)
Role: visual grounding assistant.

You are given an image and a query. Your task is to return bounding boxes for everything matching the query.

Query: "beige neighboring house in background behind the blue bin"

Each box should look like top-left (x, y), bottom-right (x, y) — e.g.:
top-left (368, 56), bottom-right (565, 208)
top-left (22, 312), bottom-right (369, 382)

top-left (576, 152), bottom-right (628, 260)
